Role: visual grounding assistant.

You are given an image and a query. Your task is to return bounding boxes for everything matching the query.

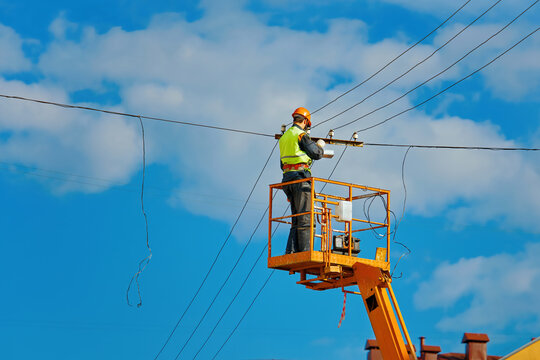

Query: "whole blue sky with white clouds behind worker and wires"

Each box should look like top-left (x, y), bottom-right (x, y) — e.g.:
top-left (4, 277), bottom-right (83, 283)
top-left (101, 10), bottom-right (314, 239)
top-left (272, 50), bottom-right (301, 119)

top-left (0, 0), bottom-right (540, 359)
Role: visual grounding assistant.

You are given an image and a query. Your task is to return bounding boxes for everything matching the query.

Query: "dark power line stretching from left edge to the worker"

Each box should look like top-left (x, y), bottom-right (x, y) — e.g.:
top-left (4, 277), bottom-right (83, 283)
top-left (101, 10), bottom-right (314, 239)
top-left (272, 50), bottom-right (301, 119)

top-left (0, 94), bottom-right (274, 137)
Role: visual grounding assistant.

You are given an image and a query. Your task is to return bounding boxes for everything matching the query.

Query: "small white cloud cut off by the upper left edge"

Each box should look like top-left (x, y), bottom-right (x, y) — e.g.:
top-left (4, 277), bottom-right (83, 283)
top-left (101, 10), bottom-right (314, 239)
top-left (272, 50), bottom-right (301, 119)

top-left (0, 24), bottom-right (31, 72)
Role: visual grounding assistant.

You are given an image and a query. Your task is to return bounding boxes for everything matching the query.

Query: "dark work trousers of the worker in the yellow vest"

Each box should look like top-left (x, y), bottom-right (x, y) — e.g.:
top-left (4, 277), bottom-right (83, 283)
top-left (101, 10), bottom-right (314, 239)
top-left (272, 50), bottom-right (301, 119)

top-left (283, 171), bottom-right (311, 254)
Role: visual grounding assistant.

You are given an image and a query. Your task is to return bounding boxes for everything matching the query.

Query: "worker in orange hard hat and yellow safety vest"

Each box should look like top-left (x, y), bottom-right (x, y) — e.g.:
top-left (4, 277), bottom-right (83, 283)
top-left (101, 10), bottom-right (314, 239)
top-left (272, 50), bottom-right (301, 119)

top-left (279, 107), bottom-right (325, 254)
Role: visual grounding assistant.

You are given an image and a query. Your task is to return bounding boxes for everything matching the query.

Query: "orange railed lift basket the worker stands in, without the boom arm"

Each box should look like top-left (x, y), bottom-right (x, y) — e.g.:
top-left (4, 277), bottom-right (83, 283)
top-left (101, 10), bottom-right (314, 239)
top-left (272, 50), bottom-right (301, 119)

top-left (268, 177), bottom-right (390, 290)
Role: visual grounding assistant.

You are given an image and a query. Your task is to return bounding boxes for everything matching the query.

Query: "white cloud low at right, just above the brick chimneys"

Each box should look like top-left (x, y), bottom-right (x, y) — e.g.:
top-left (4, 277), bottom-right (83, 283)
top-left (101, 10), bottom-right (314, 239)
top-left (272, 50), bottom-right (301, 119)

top-left (415, 244), bottom-right (540, 332)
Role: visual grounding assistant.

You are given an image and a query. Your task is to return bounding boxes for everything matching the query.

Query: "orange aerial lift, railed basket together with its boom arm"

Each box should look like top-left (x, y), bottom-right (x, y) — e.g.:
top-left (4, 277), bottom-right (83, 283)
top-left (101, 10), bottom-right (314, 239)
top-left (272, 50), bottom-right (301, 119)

top-left (268, 178), bottom-right (416, 360)
